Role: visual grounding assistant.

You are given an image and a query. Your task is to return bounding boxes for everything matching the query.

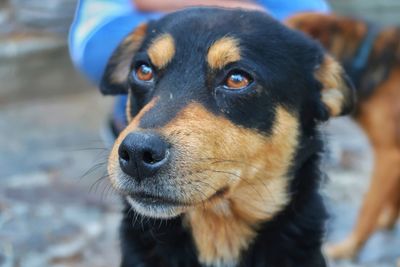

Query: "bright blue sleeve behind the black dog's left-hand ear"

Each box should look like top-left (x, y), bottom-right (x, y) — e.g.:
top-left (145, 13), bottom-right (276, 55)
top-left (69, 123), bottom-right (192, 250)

top-left (69, 0), bottom-right (161, 85)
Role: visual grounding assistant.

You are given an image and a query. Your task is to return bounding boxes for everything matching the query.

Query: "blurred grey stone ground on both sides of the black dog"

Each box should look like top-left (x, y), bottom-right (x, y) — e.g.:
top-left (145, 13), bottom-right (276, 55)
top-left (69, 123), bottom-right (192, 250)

top-left (0, 90), bottom-right (400, 267)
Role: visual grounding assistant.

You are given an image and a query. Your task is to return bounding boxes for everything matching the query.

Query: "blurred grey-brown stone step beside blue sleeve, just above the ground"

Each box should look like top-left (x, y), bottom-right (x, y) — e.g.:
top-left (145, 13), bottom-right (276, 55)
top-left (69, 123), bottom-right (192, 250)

top-left (0, 43), bottom-right (88, 105)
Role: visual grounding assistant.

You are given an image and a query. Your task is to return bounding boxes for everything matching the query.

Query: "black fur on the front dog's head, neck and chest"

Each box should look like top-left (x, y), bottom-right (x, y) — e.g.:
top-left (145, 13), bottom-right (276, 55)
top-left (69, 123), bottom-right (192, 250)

top-left (98, 8), bottom-right (354, 267)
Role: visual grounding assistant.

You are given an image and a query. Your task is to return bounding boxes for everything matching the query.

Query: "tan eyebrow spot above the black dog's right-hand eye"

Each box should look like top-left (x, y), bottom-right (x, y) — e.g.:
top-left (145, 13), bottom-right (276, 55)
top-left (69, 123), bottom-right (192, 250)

top-left (207, 37), bottom-right (240, 69)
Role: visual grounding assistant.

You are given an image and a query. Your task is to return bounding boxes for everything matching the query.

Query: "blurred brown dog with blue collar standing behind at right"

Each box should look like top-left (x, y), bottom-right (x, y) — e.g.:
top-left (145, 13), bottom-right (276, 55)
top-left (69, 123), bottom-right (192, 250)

top-left (286, 13), bottom-right (400, 258)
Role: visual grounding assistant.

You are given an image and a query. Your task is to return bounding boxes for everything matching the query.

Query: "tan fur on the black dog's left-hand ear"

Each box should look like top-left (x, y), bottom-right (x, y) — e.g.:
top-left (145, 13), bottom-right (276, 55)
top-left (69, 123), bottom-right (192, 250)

top-left (110, 24), bottom-right (147, 84)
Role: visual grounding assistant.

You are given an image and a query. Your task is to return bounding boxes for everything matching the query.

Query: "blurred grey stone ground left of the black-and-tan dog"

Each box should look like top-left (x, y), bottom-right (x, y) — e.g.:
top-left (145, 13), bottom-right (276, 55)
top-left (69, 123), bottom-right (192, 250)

top-left (0, 89), bottom-right (120, 267)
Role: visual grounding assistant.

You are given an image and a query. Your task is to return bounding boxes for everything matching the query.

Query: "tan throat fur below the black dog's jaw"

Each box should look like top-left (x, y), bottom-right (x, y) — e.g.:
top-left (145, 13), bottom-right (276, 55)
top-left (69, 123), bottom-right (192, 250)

top-left (185, 174), bottom-right (289, 266)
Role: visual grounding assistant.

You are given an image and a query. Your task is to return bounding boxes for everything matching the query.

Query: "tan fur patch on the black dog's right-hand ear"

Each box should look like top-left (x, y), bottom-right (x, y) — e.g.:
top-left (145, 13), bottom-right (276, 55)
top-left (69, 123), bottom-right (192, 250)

top-left (315, 55), bottom-right (350, 116)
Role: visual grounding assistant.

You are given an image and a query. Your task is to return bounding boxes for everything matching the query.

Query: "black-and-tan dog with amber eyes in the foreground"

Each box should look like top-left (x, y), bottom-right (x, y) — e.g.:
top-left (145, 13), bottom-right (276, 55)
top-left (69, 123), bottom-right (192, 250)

top-left (100, 7), bottom-right (354, 267)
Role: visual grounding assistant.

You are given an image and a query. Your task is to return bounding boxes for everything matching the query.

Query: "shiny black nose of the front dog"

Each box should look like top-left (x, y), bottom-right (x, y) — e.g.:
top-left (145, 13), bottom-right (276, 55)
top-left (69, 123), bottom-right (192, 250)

top-left (118, 132), bottom-right (169, 179)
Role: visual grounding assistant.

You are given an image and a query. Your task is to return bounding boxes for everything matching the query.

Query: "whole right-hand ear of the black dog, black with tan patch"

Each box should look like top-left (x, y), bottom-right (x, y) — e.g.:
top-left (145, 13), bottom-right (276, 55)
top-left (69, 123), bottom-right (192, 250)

top-left (314, 54), bottom-right (356, 121)
